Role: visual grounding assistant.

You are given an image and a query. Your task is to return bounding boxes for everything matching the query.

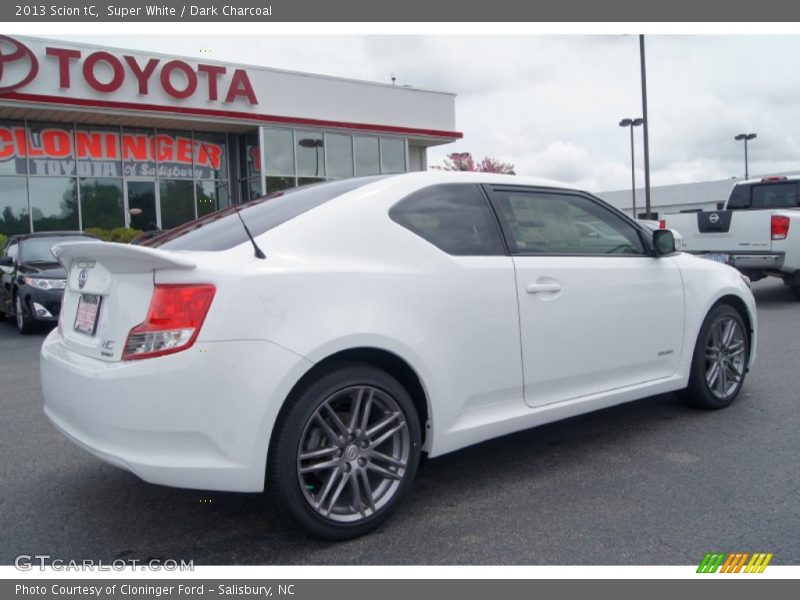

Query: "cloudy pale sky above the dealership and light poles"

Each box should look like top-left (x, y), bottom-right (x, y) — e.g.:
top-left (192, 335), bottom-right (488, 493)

top-left (47, 35), bottom-right (800, 191)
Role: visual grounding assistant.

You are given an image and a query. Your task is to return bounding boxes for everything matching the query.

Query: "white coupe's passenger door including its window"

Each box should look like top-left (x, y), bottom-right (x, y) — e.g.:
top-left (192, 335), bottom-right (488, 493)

top-left (490, 187), bottom-right (684, 407)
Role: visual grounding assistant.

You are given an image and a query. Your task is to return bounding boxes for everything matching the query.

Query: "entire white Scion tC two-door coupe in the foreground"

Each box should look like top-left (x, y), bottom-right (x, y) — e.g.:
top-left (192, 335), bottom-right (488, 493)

top-left (41, 172), bottom-right (756, 539)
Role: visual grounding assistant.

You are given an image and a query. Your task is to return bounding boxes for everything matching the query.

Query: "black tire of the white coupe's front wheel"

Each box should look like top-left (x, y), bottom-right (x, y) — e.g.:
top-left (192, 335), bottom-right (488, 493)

top-left (678, 304), bottom-right (750, 410)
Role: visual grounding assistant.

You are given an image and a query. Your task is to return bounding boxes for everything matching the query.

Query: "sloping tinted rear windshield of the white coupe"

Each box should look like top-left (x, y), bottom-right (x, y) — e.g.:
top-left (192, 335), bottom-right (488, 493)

top-left (152, 175), bottom-right (385, 251)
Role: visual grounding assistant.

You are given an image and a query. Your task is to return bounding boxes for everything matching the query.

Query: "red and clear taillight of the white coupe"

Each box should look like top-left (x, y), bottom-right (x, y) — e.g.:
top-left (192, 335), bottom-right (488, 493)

top-left (122, 284), bottom-right (216, 360)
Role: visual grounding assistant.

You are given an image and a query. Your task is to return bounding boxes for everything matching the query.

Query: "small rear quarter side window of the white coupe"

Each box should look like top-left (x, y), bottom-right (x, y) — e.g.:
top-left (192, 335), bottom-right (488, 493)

top-left (389, 184), bottom-right (505, 256)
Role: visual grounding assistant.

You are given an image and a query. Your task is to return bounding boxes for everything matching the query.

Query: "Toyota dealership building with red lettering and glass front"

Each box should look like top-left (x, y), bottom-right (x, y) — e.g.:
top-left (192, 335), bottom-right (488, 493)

top-left (0, 36), bottom-right (461, 235)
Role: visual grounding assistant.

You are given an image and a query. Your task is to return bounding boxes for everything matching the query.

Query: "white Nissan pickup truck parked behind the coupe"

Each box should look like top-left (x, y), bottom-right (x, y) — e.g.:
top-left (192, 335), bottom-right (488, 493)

top-left (660, 176), bottom-right (800, 300)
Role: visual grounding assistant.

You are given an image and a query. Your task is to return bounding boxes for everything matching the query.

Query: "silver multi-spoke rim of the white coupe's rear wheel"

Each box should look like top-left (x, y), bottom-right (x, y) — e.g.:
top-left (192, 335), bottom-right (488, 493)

top-left (297, 386), bottom-right (411, 523)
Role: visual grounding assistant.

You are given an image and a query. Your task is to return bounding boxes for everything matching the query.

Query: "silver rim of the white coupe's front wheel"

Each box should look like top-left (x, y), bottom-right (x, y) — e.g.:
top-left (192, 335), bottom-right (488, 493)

top-left (705, 315), bottom-right (747, 399)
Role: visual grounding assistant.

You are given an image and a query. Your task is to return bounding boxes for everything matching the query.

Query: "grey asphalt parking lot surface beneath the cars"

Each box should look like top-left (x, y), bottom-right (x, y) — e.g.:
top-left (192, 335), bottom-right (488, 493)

top-left (0, 281), bottom-right (800, 565)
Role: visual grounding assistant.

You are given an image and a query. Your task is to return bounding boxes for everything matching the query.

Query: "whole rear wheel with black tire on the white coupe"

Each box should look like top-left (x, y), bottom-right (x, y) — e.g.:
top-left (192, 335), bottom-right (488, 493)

top-left (267, 363), bottom-right (421, 540)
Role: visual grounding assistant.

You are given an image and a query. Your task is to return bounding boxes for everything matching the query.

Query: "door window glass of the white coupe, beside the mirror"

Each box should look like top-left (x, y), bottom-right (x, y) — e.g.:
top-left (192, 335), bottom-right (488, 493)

top-left (495, 190), bottom-right (644, 254)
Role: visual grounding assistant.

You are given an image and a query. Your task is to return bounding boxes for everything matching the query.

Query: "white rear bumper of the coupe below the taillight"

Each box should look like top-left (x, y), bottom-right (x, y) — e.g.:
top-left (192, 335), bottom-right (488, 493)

top-left (41, 331), bottom-right (311, 492)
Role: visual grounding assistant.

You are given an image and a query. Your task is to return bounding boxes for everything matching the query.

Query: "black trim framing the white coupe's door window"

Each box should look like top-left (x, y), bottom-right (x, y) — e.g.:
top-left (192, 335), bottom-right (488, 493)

top-left (481, 184), bottom-right (654, 258)
